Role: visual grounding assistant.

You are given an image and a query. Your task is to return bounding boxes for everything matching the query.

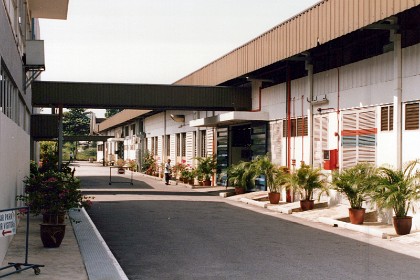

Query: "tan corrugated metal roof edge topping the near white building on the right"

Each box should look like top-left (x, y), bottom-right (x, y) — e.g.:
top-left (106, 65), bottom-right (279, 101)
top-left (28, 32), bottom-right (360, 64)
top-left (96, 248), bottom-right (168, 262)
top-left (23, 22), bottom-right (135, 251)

top-left (175, 0), bottom-right (420, 86)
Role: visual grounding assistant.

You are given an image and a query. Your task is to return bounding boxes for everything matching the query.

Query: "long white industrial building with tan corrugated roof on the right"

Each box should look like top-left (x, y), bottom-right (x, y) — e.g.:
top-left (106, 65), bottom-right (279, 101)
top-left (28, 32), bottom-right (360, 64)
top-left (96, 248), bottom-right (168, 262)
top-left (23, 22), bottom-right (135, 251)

top-left (97, 0), bottom-right (420, 228)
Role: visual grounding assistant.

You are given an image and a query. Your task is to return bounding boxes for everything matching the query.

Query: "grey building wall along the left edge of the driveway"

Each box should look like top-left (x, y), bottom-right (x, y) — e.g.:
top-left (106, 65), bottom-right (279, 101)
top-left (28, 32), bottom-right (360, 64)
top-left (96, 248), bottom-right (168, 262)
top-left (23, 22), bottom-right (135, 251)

top-left (0, 0), bottom-right (68, 261)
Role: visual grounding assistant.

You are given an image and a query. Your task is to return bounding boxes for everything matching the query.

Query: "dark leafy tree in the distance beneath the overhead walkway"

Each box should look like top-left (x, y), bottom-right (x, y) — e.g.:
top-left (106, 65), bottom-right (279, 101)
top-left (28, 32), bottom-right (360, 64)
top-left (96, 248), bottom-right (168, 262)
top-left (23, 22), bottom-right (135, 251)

top-left (63, 109), bottom-right (90, 136)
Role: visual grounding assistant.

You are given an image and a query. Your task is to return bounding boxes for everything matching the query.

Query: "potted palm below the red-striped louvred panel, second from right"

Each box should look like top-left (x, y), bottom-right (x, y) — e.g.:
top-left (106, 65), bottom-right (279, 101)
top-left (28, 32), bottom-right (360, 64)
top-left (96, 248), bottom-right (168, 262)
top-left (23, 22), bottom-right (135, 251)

top-left (331, 163), bottom-right (378, 224)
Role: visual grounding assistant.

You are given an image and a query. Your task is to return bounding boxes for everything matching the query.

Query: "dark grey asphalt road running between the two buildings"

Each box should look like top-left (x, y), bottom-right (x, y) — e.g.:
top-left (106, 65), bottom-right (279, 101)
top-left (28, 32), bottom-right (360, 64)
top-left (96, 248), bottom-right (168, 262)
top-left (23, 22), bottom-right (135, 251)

top-left (88, 189), bottom-right (420, 280)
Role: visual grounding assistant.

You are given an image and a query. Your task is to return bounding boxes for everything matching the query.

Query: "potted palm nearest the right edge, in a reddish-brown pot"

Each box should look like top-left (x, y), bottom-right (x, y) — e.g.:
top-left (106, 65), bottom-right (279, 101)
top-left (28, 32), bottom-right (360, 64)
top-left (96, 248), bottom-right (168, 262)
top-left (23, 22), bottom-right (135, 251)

top-left (371, 160), bottom-right (420, 235)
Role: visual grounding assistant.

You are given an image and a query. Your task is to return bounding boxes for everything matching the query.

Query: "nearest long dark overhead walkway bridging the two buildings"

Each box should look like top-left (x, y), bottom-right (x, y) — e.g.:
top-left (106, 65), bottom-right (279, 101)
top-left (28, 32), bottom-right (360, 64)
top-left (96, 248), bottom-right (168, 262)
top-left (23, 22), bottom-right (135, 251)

top-left (32, 81), bottom-right (252, 111)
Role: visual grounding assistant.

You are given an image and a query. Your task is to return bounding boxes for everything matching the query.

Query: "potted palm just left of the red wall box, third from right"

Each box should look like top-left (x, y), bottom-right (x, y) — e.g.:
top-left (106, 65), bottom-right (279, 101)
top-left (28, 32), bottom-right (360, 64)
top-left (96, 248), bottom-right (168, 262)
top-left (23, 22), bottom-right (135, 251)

top-left (289, 162), bottom-right (329, 211)
